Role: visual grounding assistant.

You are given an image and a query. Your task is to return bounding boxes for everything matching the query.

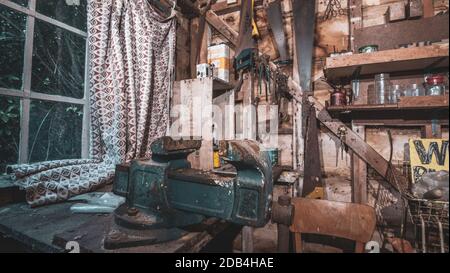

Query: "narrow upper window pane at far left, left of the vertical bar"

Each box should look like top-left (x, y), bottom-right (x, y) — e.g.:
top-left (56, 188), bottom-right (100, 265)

top-left (0, 5), bottom-right (27, 90)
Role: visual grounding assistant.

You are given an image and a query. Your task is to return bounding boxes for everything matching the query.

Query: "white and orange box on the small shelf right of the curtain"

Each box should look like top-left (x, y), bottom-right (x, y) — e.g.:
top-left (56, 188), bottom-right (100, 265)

top-left (208, 44), bottom-right (230, 82)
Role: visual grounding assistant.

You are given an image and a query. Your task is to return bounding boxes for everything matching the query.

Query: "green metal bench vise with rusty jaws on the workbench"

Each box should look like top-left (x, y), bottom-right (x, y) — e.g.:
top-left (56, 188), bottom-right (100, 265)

top-left (104, 137), bottom-right (273, 249)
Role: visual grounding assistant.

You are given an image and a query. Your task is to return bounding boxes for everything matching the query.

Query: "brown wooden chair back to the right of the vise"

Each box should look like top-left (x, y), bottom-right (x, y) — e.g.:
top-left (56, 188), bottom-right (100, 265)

top-left (290, 198), bottom-right (376, 253)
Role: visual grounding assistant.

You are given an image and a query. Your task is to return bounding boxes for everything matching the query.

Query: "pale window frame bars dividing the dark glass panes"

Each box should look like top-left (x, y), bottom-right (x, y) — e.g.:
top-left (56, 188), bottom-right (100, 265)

top-left (0, 0), bottom-right (90, 164)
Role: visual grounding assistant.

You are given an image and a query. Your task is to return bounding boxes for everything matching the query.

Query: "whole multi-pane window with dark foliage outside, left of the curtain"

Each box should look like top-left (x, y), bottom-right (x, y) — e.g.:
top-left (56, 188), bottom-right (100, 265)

top-left (0, 0), bottom-right (88, 174)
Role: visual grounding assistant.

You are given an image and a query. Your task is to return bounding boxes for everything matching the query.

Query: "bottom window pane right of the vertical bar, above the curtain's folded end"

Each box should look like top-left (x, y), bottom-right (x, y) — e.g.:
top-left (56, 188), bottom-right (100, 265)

top-left (28, 100), bottom-right (83, 162)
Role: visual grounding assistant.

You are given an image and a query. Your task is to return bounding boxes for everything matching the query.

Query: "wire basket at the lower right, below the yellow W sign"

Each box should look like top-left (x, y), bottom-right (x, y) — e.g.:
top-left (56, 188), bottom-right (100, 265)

top-left (407, 198), bottom-right (449, 252)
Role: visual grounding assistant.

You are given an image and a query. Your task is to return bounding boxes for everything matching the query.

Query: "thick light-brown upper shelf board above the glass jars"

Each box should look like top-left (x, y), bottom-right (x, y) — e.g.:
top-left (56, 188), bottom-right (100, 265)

top-left (325, 43), bottom-right (449, 82)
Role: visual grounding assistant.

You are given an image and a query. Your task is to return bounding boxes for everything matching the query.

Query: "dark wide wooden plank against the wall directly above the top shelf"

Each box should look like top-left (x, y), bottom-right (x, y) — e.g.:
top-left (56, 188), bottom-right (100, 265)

top-left (354, 13), bottom-right (449, 52)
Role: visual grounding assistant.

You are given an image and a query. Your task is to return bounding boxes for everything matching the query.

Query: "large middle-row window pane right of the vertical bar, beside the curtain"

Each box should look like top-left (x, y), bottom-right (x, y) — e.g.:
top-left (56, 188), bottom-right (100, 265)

top-left (31, 20), bottom-right (86, 98)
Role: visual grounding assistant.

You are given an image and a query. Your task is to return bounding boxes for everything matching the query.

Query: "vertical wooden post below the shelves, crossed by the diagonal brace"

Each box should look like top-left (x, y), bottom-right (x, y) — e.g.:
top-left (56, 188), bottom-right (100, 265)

top-left (351, 124), bottom-right (367, 204)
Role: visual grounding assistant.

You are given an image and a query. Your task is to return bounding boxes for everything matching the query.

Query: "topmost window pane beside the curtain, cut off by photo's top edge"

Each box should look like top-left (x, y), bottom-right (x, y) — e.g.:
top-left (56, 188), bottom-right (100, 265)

top-left (36, 0), bottom-right (87, 31)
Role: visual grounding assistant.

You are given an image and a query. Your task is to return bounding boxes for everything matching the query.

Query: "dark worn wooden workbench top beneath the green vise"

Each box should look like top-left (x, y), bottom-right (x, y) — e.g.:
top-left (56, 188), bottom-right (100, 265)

top-left (0, 182), bottom-right (230, 253)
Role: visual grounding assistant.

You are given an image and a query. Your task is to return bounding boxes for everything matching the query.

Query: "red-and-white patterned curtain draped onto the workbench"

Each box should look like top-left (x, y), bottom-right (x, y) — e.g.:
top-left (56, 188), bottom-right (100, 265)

top-left (9, 0), bottom-right (176, 207)
